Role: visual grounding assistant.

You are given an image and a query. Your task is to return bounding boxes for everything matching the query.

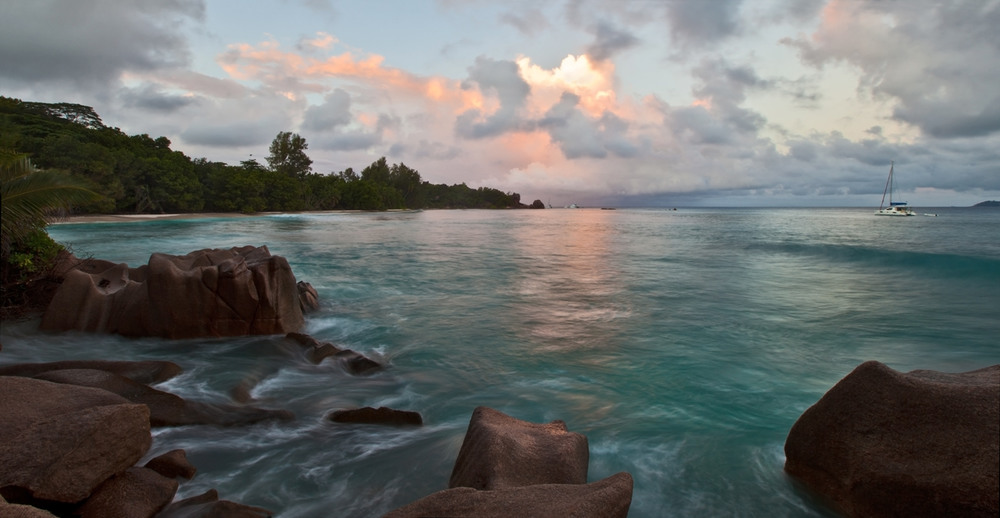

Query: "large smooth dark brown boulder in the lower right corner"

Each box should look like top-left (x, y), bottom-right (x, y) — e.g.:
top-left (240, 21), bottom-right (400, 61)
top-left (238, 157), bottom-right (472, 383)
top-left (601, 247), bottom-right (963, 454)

top-left (785, 361), bottom-right (1000, 517)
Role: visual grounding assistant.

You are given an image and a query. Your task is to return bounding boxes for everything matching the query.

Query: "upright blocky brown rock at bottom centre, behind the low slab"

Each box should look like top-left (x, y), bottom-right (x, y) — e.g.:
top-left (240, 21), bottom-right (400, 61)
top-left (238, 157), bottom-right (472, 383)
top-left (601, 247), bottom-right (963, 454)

top-left (448, 407), bottom-right (590, 489)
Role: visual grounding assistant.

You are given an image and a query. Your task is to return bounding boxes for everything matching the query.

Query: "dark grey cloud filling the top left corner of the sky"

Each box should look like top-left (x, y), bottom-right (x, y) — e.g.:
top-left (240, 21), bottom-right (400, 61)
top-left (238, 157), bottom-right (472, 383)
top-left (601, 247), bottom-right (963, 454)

top-left (0, 0), bottom-right (205, 86)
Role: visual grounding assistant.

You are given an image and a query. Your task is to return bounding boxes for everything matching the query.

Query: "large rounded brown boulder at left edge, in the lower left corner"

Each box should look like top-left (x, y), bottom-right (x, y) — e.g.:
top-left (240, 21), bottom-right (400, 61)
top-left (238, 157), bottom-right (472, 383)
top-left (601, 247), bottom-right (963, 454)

top-left (0, 376), bottom-right (152, 503)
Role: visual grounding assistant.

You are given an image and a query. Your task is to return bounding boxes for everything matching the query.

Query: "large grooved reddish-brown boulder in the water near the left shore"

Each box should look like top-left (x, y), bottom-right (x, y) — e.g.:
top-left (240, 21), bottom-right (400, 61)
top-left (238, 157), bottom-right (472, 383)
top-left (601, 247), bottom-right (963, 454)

top-left (41, 246), bottom-right (304, 338)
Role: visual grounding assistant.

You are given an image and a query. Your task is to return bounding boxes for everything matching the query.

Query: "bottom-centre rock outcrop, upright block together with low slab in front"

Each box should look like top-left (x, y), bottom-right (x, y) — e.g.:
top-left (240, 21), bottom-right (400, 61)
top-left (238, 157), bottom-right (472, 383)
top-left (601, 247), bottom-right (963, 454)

top-left (385, 407), bottom-right (633, 518)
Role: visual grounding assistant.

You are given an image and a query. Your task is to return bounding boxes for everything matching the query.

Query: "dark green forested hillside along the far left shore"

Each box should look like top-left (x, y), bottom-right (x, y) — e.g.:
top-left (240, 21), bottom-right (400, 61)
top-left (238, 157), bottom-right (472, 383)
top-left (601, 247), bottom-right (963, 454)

top-left (0, 97), bottom-right (526, 214)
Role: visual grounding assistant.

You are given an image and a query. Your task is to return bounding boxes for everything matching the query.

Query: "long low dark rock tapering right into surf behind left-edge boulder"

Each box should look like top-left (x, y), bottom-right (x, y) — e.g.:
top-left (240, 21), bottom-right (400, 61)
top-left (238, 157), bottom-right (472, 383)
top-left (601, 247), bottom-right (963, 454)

top-left (36, 369), bottom-right (295, 427)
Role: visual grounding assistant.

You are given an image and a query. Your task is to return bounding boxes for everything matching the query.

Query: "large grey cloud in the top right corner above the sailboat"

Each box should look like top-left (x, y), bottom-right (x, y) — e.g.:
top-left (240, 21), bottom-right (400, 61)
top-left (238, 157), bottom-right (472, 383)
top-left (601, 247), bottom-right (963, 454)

top-left (783, 0), bottom-right (1000, 138)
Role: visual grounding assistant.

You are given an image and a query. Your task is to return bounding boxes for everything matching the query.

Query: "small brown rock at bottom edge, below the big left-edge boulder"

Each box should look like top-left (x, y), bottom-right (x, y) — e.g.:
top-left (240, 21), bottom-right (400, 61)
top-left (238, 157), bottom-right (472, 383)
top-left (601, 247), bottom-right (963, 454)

top-left (75, 468), bottom-right (177, 518)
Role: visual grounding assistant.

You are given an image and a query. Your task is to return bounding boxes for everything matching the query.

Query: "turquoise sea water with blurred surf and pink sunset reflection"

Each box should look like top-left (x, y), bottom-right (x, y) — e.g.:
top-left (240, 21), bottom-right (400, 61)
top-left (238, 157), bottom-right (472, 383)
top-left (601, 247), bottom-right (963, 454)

top-left (0, 209), bottom-right (1000, 517)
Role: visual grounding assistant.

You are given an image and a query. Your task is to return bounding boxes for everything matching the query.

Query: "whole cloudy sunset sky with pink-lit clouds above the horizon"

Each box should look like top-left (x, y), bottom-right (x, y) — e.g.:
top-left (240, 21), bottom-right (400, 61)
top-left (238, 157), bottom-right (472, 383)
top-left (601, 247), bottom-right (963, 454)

top-left (0, 0), bottom-right (1000, 207)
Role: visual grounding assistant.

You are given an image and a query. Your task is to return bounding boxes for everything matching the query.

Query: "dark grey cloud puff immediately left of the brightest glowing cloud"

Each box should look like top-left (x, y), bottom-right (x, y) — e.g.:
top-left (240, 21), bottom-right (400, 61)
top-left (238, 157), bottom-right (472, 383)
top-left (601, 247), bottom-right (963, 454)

top-left (455, 57), bottom-right (531, 139)
